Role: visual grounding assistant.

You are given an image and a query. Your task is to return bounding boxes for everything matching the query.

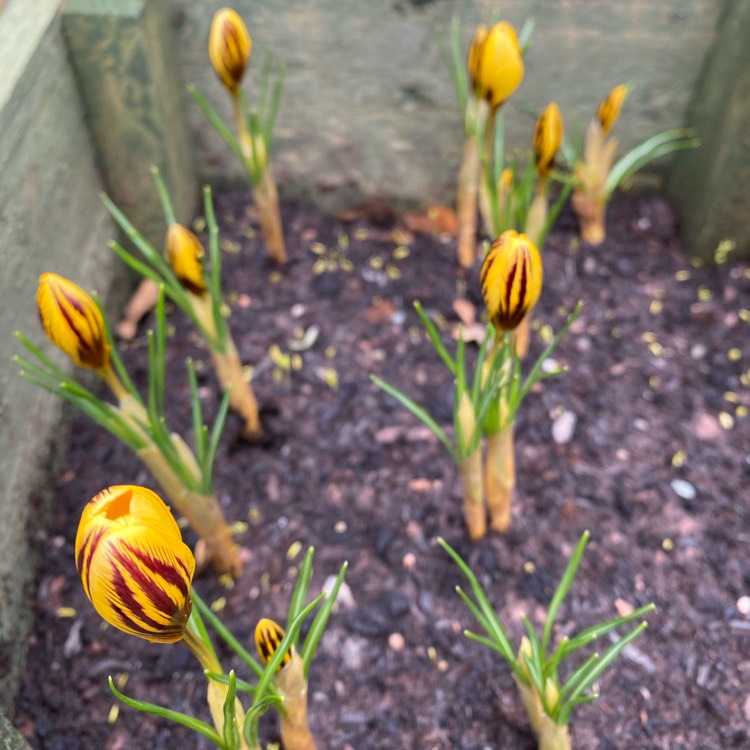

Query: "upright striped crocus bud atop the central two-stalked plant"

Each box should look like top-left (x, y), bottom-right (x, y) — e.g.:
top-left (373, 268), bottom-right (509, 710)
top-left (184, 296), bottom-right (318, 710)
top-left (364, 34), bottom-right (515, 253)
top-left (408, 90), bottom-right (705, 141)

top-left (481, 229), bottom-right (542, 332)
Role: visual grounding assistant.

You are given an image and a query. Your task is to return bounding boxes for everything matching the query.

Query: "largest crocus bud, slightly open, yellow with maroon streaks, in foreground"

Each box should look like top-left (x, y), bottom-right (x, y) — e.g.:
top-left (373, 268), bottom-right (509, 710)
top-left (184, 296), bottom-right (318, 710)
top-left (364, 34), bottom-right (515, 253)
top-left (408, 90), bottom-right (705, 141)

top-left (75, 485), bottom-right (195, 643)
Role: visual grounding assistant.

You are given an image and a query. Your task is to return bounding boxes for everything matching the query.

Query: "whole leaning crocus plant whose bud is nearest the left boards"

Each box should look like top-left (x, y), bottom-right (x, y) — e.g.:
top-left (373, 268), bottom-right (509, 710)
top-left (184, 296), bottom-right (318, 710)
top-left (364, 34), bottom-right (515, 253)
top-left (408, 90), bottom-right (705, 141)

top-left (15, 282), bottom-right (242, 575)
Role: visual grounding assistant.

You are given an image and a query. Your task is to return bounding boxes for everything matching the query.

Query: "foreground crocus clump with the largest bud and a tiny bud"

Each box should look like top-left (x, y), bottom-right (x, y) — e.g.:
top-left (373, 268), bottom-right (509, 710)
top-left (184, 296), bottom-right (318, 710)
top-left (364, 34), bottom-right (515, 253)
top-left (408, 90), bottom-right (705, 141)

top-left (75, 494), bottom-right (346, 750)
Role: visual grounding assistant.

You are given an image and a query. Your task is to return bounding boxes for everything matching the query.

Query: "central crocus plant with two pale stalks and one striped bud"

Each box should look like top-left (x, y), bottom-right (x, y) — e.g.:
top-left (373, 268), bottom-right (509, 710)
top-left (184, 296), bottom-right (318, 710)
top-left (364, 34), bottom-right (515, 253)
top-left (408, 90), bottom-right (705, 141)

top-left (371, 231), bottom-right (582, 539)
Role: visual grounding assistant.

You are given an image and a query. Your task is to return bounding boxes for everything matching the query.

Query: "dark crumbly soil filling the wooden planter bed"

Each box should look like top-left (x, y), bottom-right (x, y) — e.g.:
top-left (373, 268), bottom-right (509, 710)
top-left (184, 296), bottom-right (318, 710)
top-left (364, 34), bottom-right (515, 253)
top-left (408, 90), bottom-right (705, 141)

top-left (15, 195), bottom-right (750, 750)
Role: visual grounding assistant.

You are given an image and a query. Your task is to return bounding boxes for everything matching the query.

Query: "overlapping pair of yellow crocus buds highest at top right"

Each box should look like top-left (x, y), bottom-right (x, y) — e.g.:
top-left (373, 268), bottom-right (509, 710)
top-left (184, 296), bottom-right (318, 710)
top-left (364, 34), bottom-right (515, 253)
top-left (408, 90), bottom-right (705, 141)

top-left (467, 21), bottom-right (523, 109)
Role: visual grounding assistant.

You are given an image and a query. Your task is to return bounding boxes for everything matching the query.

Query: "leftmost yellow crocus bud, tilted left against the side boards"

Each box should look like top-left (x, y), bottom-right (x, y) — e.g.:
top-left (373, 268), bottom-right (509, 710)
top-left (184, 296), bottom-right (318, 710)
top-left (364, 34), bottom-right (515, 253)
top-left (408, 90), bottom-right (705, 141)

top-left (36, 273), bottom-right (110, 371)
